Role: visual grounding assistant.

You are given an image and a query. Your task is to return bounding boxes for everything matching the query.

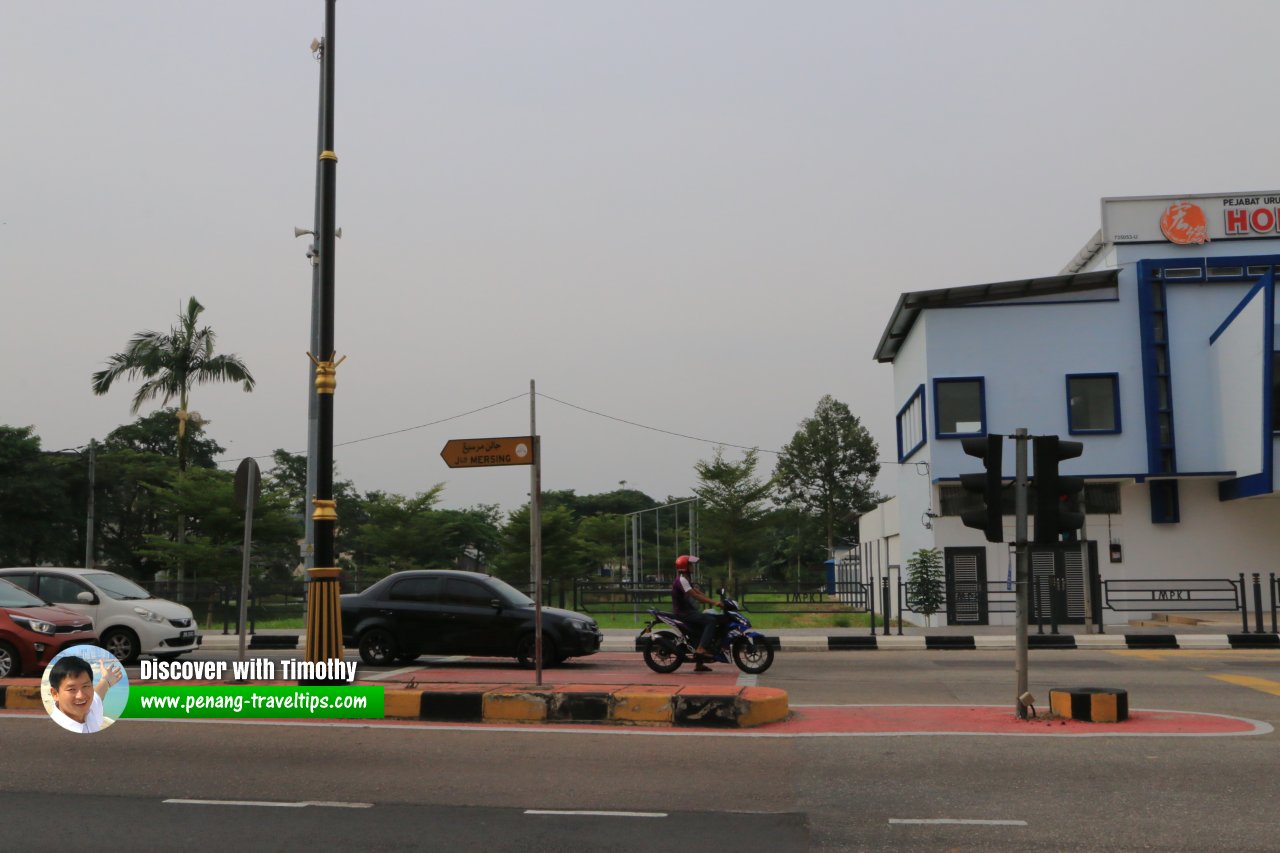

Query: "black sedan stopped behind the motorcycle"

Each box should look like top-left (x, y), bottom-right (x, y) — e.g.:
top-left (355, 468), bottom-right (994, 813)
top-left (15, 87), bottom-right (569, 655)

top-left (342, 570), bottom-right (603, 666)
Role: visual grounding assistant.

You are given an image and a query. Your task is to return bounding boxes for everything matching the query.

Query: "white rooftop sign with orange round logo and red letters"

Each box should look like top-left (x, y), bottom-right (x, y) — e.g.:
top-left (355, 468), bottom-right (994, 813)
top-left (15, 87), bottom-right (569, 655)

top-left (1102, 191), bottom-right (1280, 246)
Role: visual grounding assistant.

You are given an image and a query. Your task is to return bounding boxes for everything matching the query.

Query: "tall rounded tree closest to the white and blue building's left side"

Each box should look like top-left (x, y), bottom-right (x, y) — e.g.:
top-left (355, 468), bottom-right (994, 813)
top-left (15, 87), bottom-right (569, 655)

top-left (773, 394), bottom-right (879, 555)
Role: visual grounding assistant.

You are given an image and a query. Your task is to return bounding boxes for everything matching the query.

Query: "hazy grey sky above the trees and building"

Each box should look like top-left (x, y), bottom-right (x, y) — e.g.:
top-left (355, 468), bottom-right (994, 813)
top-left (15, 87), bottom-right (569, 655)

top-left (0, 0), bottom-right (1280, 507)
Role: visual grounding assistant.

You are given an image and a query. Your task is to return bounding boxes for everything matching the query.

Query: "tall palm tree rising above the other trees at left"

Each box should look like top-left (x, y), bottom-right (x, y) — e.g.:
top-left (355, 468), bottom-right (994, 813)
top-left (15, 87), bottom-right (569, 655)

top-left (92, 296), bottom-right (253, 471)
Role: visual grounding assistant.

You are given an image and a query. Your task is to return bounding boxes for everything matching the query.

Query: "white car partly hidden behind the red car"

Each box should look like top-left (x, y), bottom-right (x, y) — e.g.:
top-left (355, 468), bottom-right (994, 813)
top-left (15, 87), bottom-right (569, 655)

top-left (0, 566), bottom-right (201, 663)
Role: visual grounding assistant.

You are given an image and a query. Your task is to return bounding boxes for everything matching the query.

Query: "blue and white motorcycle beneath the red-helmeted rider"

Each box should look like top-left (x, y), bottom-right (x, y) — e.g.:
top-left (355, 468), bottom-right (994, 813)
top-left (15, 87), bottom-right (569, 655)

top-left (640, 589), bottom-right (773, 675)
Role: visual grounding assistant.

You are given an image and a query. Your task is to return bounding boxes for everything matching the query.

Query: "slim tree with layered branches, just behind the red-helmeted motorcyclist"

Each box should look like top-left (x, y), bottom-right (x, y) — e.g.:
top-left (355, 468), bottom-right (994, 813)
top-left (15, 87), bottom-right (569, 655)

top-left (694, 447), bottom-right (773, 587)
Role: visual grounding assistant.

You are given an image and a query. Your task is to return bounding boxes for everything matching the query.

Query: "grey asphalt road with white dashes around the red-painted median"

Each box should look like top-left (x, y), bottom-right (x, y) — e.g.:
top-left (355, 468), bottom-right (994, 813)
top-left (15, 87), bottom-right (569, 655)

top-left (0, 651), bottom-right (1280, 852)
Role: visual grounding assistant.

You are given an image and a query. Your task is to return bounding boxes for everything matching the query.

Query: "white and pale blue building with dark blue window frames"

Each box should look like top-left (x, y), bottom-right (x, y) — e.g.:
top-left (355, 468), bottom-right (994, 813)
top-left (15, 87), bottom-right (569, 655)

top-left (861, 192), bottom-right (1280, 624)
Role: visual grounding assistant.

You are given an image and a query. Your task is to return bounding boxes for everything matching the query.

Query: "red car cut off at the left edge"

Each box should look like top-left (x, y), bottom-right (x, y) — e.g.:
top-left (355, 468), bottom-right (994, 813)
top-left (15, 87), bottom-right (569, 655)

top-left (0, 580), bottom-right (97, 679)
